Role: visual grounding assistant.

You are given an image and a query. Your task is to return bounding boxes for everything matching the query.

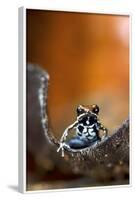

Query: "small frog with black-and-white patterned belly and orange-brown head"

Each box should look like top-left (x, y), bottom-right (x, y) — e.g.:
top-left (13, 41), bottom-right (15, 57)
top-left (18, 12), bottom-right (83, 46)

top-left (57, 104), bottom-right (108, 157)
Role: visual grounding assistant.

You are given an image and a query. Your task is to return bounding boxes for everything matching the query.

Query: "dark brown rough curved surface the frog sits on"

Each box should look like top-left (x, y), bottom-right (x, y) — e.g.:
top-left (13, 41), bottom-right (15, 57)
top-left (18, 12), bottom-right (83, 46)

top-left (27, 64), bottom-right (129, 190)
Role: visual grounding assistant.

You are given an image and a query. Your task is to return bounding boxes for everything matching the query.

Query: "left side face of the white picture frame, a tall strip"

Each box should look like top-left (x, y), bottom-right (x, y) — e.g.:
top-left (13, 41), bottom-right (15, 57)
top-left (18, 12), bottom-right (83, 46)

top-left (18, 7), bottom-right (26, 193)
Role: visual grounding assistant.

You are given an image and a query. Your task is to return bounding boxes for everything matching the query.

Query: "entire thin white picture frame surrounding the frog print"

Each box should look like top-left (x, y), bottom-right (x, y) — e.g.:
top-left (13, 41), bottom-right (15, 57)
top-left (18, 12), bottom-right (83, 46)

top-left (18, 6), bottom-right (133, 193)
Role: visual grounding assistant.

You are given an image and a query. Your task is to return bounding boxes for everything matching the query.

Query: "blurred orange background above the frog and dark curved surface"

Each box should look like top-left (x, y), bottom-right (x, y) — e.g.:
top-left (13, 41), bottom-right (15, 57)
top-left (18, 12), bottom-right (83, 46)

top-left (27, 10), bottom-right (129, 138)
